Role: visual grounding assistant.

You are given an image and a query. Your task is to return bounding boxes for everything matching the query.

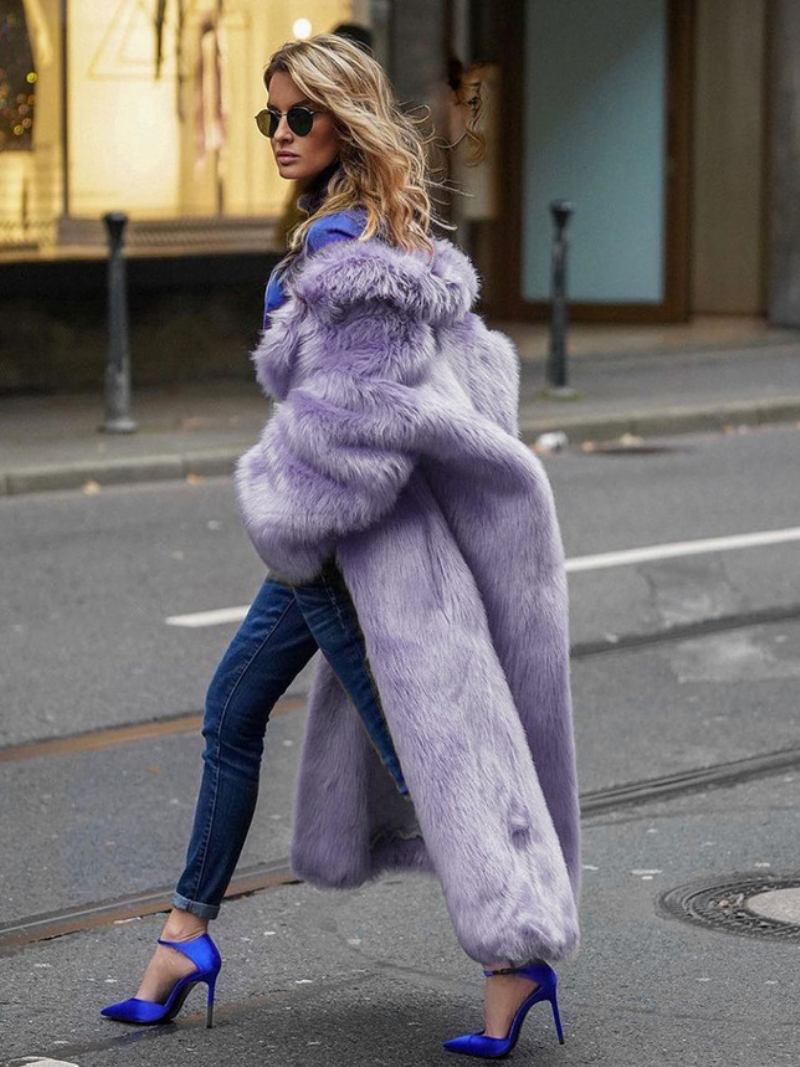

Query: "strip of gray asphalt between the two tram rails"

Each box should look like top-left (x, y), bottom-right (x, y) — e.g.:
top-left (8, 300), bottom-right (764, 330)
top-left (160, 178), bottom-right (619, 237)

top-left (0, 620), bottom-right (800, 923)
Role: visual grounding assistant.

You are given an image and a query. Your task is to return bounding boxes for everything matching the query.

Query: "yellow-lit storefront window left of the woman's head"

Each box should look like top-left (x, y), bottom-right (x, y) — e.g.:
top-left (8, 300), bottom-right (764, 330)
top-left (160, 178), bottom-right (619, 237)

top-left (0, 0), bottom-right (353, 258)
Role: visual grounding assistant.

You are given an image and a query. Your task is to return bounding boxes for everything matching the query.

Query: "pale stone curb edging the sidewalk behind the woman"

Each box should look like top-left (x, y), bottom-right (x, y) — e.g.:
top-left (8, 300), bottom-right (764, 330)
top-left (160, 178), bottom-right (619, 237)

top-left (0, 395), bottom-right (800, 496)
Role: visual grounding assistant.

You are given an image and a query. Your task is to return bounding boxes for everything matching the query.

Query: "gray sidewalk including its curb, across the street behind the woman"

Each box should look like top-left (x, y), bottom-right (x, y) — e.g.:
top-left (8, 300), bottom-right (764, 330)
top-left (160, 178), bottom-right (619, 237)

top-left (0, 337), bottom-right (800, 495)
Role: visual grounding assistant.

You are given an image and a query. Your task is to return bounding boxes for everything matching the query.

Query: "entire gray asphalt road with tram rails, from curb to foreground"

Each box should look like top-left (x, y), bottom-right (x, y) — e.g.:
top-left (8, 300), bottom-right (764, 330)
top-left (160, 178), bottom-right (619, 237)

top-left (0, 427), bottom-right (800, 1067)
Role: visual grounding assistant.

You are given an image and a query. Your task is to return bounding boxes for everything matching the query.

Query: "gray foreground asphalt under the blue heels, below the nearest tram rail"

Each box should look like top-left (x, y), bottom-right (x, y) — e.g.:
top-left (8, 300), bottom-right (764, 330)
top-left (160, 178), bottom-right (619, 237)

top-left (0, 774), bottom-right (800, 1067)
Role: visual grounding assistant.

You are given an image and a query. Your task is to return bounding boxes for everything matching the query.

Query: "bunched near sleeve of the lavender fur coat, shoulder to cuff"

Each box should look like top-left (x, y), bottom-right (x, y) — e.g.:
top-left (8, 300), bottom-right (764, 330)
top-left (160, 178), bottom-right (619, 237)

top-left (236, 236), bottom-right (456, 584)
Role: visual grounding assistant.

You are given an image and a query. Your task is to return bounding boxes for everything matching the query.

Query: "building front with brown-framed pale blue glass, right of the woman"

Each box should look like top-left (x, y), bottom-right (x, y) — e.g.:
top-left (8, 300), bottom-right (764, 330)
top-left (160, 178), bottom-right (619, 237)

top-left (455, 0), bottom-right (800, 325)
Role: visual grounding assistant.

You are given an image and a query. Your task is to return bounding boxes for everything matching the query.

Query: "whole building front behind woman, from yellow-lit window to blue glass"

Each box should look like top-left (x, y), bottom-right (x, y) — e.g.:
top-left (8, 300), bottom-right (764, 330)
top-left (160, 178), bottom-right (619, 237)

top-left (0, 0), bottom-right (800, 388)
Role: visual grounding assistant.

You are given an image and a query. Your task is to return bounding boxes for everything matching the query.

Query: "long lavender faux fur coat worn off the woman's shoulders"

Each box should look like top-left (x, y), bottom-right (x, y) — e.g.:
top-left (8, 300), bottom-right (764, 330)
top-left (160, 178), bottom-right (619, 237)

top-left (236, 231), bottom-right (580, 964)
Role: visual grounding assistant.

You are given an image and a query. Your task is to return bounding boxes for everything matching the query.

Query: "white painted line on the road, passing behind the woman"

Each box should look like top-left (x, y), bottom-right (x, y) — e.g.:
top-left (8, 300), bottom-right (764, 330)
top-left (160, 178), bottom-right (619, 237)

top-left (164, 526), bottom-right (800, 627)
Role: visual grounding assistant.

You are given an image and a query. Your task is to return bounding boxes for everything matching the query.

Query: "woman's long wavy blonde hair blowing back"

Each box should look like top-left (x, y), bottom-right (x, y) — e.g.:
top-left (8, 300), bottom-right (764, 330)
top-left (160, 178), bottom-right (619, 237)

top-left (263, 33), bottom-right (462, 253)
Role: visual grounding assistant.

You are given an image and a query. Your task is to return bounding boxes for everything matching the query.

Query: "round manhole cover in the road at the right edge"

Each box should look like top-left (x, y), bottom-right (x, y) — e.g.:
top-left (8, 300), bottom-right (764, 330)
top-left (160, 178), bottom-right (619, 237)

top-left (659, 872), bottom-right (800, 941)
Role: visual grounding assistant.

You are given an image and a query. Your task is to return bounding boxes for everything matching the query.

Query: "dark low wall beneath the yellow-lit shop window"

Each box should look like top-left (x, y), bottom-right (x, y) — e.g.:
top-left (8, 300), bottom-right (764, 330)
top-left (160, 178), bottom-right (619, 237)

top-left (0, 255), bottom-right (277, 393)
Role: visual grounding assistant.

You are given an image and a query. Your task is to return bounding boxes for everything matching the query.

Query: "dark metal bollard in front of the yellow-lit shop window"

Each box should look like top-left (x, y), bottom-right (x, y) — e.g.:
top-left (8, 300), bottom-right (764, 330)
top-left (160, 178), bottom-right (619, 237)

top-left (98, 211), bottom-right (138, 433)
